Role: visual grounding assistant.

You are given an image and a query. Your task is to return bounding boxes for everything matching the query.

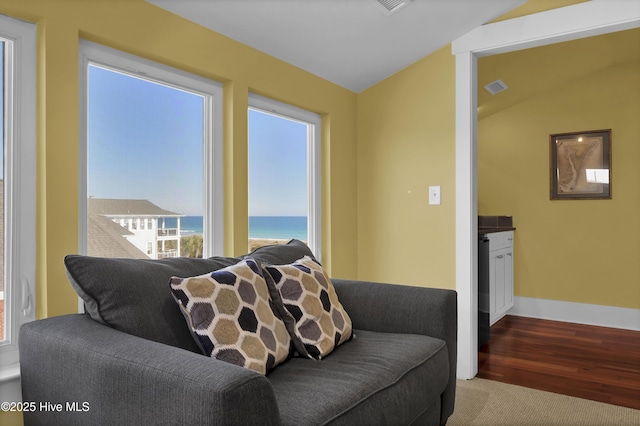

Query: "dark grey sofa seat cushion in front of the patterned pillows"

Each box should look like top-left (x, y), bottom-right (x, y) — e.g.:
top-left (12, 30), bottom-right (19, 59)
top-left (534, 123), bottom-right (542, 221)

top-left (268, 330), bottom-right (449, 425)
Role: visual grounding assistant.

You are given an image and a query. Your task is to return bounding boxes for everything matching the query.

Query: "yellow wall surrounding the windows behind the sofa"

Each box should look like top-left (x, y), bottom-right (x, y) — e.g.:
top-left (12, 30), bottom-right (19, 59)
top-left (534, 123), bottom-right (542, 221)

top-left (0, 0), bottom-right (357, 318)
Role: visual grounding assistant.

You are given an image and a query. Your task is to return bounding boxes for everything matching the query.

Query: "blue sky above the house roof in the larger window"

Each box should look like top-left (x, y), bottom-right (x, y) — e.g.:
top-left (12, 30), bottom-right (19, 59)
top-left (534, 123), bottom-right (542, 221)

top-left (87, 66), bottom-right (203, 215)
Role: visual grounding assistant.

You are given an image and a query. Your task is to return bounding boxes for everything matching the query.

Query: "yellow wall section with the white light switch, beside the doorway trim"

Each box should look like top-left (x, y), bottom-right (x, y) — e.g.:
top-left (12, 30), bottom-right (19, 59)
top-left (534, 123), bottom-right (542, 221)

top-left (358, 46), bottom-right (455, 288)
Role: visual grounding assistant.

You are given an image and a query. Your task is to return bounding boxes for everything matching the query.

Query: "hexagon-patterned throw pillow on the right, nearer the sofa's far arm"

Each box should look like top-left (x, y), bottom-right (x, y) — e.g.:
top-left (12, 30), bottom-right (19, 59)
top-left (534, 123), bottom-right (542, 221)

top-left (263, 256), bottom-right (352, 359)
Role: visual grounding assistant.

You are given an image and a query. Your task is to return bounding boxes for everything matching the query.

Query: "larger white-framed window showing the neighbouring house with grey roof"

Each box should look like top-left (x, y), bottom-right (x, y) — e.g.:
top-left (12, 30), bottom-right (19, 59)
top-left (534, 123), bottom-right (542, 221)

top-left (80, 41), bottom-right (223, 258)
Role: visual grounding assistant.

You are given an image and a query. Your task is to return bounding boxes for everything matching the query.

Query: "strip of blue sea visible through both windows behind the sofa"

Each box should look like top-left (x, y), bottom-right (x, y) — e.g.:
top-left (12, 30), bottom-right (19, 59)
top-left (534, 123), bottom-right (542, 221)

top-left (166, 216), bottom-right (308, 241)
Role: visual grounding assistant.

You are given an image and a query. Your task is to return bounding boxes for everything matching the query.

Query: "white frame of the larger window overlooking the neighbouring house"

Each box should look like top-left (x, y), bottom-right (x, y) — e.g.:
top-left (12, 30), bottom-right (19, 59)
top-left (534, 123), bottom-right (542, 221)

top-left (78, 40), bottom-right (224, 266)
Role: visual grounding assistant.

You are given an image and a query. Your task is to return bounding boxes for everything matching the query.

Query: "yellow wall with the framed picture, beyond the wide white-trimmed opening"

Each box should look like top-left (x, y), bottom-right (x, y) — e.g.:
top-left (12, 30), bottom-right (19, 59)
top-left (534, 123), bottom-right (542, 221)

top-left (478, 30), bottom-right (640, 309)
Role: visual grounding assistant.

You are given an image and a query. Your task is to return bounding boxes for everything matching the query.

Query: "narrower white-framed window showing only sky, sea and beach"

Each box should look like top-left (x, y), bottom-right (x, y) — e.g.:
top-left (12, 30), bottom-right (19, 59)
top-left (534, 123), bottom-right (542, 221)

top-left (248, 95), bottom-right (321, 256)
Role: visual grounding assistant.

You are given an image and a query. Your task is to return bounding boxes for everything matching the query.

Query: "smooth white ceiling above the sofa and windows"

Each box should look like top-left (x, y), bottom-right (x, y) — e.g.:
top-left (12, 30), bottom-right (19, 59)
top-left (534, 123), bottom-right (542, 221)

top-left (147, 0), bottom-right (526, 93)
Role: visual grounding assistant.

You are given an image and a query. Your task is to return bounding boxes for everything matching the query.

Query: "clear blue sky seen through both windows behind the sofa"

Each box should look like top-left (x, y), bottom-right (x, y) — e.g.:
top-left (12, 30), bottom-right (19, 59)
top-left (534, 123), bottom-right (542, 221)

top-left (87, 66), bottom-right (307, 216)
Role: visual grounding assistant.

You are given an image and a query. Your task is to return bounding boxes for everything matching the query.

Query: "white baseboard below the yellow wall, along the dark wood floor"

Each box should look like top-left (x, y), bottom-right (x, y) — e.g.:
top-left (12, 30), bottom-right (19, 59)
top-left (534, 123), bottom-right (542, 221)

top-left (507, 296), bottom-right (640, 331)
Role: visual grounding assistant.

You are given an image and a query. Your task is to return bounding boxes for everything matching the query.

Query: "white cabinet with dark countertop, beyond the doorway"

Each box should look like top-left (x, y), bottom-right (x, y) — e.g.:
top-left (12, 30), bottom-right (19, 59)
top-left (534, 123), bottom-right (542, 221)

top-left (487, 231), bottom-right (513, 325)
